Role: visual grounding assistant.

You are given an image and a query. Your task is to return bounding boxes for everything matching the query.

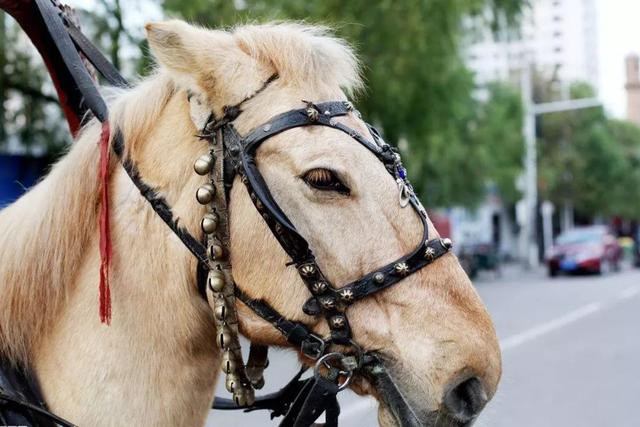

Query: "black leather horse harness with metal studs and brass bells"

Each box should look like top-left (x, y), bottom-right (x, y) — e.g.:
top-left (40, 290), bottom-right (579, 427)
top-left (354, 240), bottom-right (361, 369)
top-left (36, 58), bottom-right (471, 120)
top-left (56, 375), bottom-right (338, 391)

top-left (0, 0), bottom-right (451, 427)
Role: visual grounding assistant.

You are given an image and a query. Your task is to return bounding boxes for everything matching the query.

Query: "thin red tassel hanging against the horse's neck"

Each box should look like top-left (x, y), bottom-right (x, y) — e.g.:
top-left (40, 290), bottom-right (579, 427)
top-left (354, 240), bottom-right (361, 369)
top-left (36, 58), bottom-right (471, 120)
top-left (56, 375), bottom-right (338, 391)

top-left (99, 120), bottom-right (111, 325)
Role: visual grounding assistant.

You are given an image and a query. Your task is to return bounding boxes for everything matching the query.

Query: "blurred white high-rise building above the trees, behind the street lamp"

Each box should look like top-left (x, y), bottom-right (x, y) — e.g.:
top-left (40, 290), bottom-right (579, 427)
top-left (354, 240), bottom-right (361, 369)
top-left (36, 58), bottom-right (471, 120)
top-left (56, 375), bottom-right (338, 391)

top-left (466, 0), bottom-right (598, 91)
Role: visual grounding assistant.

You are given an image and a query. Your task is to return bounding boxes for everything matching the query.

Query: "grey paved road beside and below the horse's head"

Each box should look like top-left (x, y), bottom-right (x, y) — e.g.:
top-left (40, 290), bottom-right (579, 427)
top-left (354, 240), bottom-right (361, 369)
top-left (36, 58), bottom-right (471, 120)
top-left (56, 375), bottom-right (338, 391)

top-left (208, 269), bottom-right (640, 427)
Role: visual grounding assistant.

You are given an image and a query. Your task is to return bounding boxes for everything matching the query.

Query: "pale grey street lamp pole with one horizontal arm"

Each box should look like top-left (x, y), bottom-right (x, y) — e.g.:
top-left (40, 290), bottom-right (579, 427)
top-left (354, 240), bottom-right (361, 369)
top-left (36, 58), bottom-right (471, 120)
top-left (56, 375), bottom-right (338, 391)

top-left (519, 60), bottom-right (602, 268)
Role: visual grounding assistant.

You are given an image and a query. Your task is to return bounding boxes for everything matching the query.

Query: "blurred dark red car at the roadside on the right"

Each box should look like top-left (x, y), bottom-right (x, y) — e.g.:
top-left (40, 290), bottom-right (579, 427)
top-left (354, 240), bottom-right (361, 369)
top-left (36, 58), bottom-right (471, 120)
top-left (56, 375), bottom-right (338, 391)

top-left (547, 225), bottom-right (622, 276)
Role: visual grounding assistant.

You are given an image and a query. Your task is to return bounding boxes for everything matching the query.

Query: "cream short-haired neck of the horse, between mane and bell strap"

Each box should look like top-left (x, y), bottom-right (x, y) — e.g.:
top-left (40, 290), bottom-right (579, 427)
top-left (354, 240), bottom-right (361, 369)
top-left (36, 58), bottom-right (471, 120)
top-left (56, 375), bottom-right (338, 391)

top-left (28, 86), bottom-right (218, 426)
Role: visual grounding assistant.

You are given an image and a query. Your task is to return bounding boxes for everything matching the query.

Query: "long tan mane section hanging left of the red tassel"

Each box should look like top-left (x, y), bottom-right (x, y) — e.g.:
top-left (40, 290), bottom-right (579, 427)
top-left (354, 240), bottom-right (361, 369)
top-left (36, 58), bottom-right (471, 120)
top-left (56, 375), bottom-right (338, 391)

top-left (0, 127), bottom-right (99, 361)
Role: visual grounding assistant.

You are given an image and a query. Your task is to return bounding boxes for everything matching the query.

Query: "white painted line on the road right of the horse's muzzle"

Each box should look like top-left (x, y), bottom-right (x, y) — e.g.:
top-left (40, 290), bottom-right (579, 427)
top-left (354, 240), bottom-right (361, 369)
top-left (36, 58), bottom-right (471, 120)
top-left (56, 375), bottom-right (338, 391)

top-left (500, 287), bottom-right (640, 351)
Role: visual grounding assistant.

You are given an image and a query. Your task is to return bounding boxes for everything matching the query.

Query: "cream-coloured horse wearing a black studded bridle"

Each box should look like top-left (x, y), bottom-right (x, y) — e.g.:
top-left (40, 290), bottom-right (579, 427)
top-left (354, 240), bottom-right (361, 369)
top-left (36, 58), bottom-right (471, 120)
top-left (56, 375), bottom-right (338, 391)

top-left (0, 21), bottom-right (501, 426)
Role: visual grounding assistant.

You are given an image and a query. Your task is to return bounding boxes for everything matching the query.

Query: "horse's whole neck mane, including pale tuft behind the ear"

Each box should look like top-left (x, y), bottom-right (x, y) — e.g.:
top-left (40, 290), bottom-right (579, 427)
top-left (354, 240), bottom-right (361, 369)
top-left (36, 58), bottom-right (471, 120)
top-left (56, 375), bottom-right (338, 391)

top-left (0, 73), bottom-right (174, 363)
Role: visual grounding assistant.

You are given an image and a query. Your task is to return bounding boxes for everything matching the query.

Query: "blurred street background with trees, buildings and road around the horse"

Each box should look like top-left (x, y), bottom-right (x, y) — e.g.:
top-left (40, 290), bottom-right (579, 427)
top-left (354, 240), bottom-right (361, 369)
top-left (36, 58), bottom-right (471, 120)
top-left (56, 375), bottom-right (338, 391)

top-left (0, 0), bottom-right (640, 426)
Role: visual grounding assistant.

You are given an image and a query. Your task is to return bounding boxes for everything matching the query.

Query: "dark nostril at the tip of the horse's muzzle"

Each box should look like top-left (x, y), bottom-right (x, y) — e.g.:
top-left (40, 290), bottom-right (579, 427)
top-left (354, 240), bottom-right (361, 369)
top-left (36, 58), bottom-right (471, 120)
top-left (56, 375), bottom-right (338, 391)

top-left (442, 377), bottom-right (489, 422)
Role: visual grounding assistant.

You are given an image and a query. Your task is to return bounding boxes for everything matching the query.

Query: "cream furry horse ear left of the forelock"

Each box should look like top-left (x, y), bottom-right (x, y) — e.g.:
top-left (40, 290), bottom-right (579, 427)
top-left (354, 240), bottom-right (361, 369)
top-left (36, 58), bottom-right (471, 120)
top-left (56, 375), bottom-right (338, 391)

top-left (145, 20), bottom-right (198, 73)
